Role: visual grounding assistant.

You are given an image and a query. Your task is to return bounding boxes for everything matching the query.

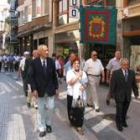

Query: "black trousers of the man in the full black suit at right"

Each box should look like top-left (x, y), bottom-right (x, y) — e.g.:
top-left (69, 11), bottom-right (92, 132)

top-left (116, 99), bottom-right (130, 125)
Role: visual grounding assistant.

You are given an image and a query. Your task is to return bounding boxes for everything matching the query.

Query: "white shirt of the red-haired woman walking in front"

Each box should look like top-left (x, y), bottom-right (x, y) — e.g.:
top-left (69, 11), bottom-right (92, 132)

top-left (66, 69), bottom-right (88, 96)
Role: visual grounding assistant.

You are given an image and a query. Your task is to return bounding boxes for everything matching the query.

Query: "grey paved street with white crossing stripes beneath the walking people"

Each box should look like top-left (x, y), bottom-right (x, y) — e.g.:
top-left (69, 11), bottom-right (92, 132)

top-left (0, 73), bottom-right (140, 140)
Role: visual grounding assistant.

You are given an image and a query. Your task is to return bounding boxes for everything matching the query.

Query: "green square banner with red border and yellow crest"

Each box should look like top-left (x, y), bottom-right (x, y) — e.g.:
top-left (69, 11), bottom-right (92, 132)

top-left (80, 6), bottom-right (117, 45)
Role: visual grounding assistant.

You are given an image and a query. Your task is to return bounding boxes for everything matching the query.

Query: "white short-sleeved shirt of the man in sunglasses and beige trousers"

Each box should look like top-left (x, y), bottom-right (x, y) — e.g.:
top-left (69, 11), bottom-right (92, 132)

top-left (83, 58), bottom-right (104, 75)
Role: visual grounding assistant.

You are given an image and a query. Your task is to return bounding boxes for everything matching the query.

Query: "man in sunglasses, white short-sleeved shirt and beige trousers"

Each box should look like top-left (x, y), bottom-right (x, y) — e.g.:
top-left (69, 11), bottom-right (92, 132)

top-left (83, 51), bottom-right (104, 112)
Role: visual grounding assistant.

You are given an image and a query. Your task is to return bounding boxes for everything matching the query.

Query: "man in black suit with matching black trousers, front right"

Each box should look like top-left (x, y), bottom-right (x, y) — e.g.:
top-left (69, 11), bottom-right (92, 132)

top-left (110, 58), bottom-right (138, 131)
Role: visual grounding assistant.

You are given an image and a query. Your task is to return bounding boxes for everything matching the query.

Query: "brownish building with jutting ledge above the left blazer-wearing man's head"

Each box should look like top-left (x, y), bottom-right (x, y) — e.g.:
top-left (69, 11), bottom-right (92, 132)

top-left (17, 0), bottom-right (54, 54)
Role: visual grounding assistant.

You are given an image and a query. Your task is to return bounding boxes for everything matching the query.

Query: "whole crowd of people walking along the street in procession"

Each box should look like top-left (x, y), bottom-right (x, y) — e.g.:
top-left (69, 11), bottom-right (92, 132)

top-left (0, 45), bottom-right (139, 137)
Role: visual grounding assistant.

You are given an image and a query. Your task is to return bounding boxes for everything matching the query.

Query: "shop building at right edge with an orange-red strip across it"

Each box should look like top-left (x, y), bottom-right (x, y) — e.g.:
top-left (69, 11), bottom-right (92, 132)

top-left (122, 0), bottom-right (140, 69)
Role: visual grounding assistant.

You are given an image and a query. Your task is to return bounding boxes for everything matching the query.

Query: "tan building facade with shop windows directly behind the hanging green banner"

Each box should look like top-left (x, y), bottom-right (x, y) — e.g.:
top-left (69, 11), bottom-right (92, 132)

top-left (53, 0), bottom-right (122, 66)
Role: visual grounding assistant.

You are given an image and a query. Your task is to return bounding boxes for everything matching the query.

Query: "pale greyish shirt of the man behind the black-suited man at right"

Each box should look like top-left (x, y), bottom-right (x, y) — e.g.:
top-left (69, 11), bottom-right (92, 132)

top-left (106, 57), bottom-right (121, 74)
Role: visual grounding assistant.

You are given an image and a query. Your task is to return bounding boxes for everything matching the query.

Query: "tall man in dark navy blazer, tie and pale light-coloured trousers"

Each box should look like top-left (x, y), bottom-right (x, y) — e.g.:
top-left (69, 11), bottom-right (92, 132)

top-left (29, 45), bottom-right (58, 137)
